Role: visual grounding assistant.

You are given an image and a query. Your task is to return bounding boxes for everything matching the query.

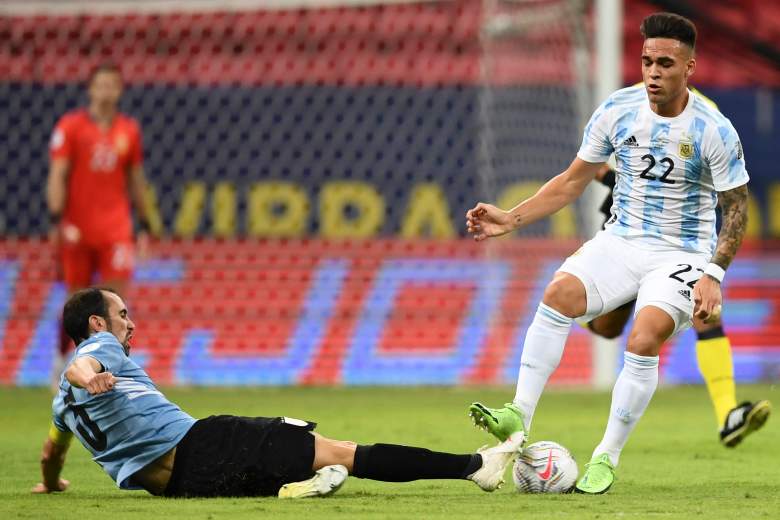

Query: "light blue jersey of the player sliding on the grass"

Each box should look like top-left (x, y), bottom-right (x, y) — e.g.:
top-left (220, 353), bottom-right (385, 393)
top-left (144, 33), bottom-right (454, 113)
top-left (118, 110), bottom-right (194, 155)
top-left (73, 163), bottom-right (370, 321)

top-left (52, 332), bottom-right (195, 489)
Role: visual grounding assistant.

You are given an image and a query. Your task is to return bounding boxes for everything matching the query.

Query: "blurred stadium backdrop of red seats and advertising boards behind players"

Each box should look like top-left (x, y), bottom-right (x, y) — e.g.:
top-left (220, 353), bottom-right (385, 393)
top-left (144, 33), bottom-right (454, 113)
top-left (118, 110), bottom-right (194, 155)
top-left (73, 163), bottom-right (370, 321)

top-left (0, 0), bottom-right (780, 385)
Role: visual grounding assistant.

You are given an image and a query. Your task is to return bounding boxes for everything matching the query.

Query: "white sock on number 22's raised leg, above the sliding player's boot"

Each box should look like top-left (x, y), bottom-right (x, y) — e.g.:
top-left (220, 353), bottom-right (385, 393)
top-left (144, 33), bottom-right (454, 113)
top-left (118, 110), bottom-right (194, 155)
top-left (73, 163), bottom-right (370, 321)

top-left (512, 303), bottom-right (574, 432)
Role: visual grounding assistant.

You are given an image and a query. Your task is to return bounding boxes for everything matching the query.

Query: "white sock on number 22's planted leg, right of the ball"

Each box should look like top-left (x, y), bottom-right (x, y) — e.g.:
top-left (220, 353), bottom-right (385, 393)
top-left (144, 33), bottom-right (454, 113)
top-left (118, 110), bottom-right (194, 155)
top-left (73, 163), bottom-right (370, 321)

top-left (593, 352), bottom-right (658, 466)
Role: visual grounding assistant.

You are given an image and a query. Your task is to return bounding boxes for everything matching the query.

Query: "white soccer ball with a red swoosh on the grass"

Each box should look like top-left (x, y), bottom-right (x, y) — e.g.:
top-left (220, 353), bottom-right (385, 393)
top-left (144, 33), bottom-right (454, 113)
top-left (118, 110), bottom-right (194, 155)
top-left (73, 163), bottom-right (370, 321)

top-left (512, 441), bottom-right (578, 493)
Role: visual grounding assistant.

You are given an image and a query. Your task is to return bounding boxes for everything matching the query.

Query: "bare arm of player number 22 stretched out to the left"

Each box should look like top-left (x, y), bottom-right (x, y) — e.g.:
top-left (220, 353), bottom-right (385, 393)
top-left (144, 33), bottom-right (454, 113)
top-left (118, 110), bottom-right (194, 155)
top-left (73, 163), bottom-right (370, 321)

top-left (466, 157), bottom-right (603, 242)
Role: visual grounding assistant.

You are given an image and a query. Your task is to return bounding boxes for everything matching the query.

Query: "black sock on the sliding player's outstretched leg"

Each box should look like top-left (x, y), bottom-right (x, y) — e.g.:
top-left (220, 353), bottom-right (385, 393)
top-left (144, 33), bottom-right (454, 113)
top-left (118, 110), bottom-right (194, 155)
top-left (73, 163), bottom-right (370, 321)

top-left (352, 444), bottom-right (482, 482)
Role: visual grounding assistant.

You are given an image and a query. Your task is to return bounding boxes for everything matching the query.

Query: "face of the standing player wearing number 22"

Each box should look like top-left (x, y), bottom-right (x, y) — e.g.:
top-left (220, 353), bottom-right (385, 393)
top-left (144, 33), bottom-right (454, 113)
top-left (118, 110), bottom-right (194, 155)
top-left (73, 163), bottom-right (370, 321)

top-left (642, 38), bottom-right (696, 105)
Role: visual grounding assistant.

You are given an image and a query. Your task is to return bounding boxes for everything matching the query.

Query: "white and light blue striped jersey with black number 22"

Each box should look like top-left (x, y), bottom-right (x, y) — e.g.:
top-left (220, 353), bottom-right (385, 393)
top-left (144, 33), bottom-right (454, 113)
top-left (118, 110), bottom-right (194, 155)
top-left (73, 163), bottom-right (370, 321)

top-left (577, 85), bottom-right (749, 255)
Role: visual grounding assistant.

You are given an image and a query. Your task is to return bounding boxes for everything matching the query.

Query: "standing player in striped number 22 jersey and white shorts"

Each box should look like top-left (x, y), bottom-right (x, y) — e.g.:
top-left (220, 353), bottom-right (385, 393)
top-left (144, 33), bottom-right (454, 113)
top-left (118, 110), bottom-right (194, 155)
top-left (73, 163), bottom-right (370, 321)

top-left (466, 13), bottom-right (748, 494)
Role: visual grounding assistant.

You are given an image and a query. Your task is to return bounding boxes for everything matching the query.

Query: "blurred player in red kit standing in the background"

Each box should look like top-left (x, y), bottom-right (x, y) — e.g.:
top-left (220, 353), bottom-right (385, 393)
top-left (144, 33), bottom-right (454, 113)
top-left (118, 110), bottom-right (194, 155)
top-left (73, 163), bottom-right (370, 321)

top-left (46, 64), bottom-right (149, 369)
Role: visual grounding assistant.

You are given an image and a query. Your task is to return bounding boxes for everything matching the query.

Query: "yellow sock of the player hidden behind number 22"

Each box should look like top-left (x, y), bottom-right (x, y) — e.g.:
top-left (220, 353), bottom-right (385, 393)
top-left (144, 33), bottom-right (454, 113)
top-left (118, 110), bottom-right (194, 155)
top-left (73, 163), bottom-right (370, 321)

top-left (696, 336), bottom-right (737, 428)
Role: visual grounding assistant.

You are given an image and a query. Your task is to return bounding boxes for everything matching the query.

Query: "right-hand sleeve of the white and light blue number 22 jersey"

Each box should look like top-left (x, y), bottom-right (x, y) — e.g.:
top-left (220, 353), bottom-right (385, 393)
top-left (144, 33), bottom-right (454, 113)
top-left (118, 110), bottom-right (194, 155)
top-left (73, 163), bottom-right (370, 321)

top-left (707, 122), bottom-right (750, 191)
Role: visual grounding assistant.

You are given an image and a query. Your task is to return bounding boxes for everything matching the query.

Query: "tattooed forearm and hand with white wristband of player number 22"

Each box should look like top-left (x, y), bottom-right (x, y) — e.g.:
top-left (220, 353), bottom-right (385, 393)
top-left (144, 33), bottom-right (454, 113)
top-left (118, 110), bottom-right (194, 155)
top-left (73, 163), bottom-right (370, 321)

top-left (693, 185), bottom-right (748, 321)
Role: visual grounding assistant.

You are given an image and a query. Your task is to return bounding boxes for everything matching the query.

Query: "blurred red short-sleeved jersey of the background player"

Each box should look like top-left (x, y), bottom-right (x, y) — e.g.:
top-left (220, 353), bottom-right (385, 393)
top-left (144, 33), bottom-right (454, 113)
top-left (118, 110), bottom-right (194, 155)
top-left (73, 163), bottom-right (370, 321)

top-left (49, 109), bottom-right (143, 245)
